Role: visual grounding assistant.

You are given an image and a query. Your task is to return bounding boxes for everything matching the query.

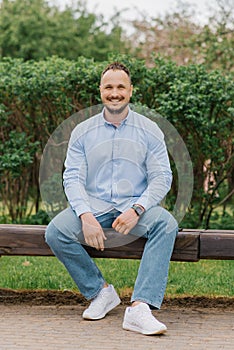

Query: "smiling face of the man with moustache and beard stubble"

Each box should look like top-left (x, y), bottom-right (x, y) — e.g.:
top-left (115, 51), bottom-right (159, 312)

top-left (100, 69), bottom-right (132, 114)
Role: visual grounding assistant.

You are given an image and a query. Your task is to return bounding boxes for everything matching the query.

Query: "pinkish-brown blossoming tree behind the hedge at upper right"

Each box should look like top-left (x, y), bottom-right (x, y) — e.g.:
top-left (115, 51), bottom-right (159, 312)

top-left (128, 0), bottom-right (234, 72)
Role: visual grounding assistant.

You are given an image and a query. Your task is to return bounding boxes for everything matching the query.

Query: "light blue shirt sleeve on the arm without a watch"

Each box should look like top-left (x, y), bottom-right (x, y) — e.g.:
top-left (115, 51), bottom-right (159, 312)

top-left (63, 130), bottom-right (91, 216)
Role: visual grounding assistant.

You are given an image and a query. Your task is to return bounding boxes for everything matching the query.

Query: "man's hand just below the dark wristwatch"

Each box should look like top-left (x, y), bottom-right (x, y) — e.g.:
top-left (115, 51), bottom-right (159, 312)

top-left (112, 208), bottom-right (139, 235)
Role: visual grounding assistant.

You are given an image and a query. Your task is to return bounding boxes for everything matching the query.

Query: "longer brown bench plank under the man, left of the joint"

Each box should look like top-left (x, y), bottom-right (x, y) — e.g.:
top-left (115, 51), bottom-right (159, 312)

top-left (0, 224), bottom-right (200, 261)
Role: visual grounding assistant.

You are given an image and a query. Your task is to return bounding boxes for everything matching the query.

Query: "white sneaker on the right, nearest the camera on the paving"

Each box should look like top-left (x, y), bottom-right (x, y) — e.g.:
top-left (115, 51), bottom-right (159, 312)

top-left (123, 303), bottom-right (167, 335)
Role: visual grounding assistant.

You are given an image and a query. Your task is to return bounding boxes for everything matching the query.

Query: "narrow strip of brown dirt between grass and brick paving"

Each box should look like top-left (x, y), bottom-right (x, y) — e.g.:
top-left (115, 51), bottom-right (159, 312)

top-left (0, 289), bottom-right (234, 310)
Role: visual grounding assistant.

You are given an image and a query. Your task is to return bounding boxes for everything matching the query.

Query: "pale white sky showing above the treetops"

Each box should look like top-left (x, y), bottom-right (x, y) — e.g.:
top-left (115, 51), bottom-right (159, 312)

top-left (54, 0), bottom-right (217, 23)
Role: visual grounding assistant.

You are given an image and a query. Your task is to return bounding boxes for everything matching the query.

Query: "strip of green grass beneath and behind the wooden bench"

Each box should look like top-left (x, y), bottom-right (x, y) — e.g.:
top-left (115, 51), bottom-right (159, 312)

top-left (0, 256), bottom-right (234, 297)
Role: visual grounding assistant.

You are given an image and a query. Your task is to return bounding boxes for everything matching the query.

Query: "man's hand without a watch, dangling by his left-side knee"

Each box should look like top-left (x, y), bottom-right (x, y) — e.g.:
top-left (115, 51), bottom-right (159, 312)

top-left (80, 213), bottom-right (106, 251)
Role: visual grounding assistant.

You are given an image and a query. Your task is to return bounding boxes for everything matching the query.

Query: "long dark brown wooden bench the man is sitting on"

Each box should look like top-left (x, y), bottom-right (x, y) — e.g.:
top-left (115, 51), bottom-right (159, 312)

top-left (0, 224), bottom-right (234, 261)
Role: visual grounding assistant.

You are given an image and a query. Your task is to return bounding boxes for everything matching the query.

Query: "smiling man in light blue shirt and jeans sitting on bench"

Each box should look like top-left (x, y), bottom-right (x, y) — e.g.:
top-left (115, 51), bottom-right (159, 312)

top-left (46, 62), bottom-right (177, 335)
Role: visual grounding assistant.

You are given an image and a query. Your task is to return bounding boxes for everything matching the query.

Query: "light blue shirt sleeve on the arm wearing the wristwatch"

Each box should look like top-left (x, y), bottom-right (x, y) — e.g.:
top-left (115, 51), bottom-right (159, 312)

top-left (137, 125), bottom-right (172, 210)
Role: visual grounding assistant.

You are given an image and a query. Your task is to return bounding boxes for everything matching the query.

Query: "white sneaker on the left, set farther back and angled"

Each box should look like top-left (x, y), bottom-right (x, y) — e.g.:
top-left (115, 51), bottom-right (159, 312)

top-left (82, 284), bottom-right (121, 320)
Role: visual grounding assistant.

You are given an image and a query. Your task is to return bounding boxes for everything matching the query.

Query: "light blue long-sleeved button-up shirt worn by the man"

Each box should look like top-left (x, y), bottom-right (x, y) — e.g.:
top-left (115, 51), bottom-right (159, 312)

top-left (64, 109), bottom-right (172, 216)
